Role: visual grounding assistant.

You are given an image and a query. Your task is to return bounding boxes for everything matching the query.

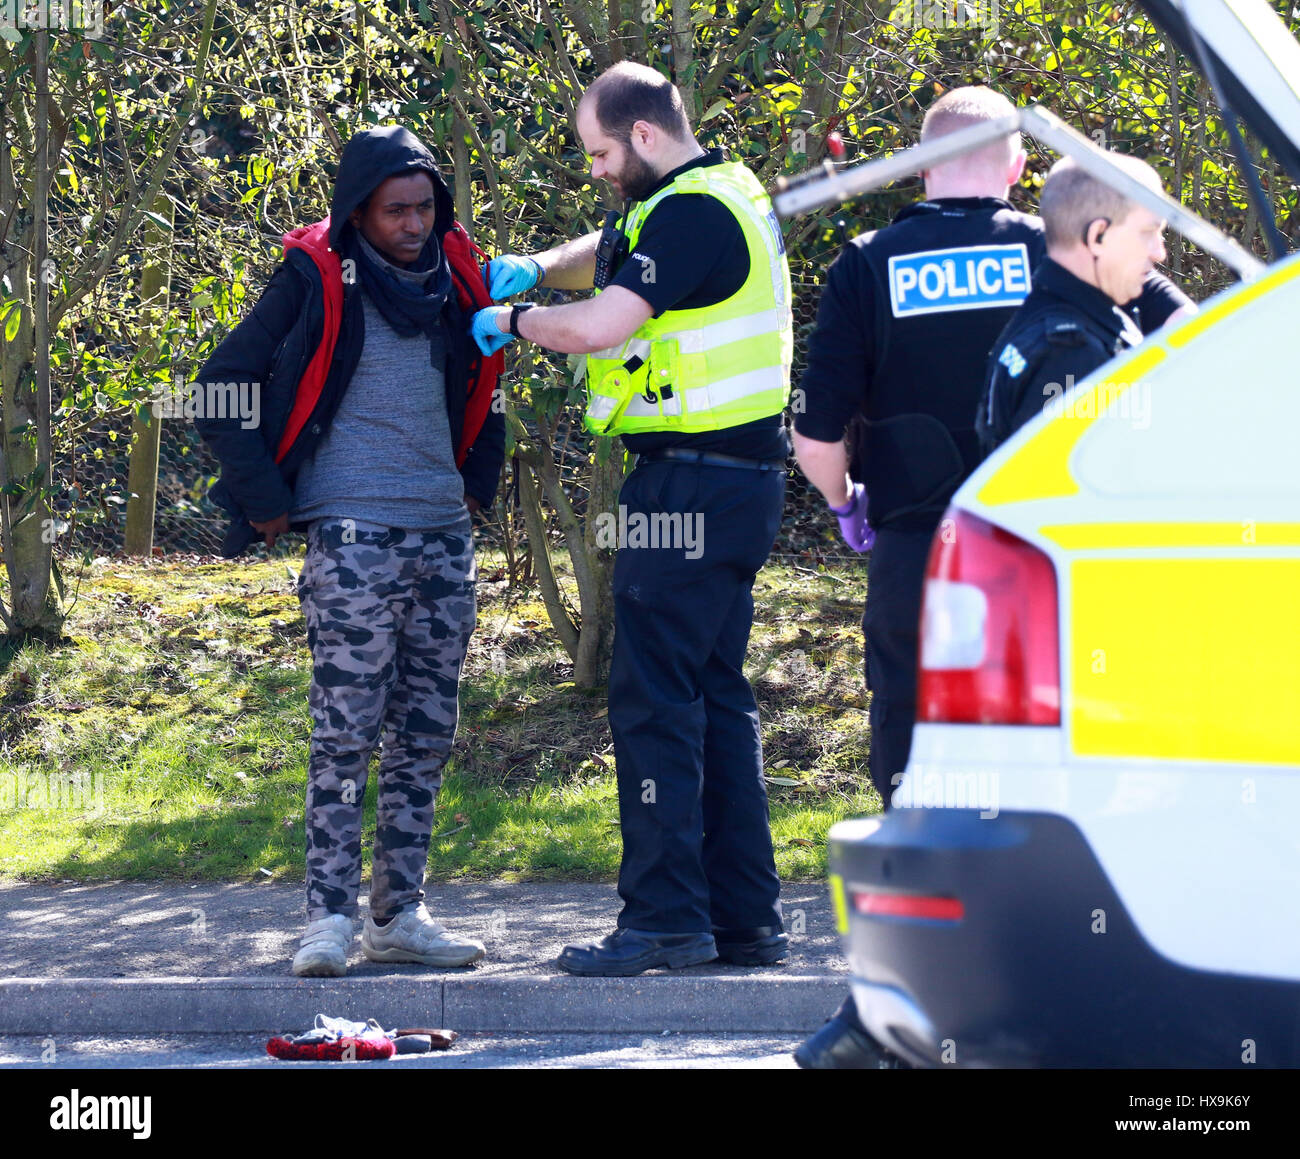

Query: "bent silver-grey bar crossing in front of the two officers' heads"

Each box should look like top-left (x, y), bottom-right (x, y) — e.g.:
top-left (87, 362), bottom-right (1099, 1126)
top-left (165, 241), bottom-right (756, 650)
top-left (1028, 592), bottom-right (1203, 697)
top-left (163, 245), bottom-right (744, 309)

top-left (772, 105), bottom-right (1265, 282)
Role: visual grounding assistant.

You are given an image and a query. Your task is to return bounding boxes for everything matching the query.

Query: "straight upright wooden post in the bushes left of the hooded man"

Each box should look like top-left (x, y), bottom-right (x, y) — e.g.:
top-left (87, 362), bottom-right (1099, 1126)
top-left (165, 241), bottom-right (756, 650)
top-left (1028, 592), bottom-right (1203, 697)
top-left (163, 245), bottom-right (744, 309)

top-left (125, 194), bottom-right (174, 556)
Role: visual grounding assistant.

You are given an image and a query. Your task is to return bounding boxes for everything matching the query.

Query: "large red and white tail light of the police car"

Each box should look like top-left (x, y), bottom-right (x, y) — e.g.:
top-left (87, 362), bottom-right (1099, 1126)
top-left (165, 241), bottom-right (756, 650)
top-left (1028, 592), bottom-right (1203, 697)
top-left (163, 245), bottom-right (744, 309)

top-left (917, 508), bottom-right (1061, 725)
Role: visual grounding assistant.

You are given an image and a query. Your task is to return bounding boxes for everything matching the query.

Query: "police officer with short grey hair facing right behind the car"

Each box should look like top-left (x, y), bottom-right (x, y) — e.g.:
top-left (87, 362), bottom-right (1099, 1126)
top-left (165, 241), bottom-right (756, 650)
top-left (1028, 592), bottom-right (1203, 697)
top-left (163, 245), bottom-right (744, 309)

top-left (978, 153), bottom-right (1195, 453)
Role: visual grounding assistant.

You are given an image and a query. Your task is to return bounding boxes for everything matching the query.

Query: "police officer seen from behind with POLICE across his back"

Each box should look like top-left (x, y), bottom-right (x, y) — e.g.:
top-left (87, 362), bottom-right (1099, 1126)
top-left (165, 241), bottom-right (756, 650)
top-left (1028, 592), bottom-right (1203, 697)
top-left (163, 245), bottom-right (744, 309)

top-left (794, 87), bottom-right (1195, 1069)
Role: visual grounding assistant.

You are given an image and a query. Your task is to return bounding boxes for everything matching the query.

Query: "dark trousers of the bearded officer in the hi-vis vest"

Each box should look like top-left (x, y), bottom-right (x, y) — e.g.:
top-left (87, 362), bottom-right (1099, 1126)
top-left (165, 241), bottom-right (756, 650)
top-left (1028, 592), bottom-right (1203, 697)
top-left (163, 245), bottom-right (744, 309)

top-left (610, 461), bottom-right (785, 933)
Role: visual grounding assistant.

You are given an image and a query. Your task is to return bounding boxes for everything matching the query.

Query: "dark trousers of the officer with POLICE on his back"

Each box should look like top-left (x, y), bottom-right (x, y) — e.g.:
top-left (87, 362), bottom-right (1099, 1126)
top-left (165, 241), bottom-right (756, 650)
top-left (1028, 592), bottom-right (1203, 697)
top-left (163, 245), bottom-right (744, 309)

top-left (862, 528), bottom-right (933, 809)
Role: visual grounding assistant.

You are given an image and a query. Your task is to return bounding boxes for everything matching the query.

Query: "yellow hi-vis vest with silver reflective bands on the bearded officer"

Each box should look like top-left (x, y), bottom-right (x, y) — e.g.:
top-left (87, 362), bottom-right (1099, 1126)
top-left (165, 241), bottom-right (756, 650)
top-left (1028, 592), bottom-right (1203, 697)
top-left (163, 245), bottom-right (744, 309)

top-left (585, 161), bottom-right (794, 435)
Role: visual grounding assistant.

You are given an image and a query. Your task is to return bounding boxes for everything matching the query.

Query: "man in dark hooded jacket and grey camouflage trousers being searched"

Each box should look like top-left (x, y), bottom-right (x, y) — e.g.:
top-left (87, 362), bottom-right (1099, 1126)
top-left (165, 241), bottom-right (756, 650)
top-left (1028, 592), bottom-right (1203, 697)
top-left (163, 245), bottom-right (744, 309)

top-left (196, 126), bottom-right (504, 976)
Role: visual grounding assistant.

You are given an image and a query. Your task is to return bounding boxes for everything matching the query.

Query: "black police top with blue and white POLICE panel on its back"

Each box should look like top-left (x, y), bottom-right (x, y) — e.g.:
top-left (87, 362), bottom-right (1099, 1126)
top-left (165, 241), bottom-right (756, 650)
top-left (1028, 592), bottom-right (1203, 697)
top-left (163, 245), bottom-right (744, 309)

top-left (794, 197), bottom-right (1045, 530)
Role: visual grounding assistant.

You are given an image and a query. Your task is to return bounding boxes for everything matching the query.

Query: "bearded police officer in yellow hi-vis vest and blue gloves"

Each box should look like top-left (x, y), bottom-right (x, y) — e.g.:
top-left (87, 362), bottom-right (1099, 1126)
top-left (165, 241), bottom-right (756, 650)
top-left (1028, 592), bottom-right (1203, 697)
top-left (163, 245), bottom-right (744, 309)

top-left (473, 62), bottom-right (793, 976)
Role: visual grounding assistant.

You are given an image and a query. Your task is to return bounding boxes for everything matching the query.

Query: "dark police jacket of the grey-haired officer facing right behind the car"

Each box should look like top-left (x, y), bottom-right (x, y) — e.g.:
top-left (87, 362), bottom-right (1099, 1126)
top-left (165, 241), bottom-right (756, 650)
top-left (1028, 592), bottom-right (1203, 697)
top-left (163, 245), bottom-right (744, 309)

top-left (976, 257), bottom-right (1141, 455)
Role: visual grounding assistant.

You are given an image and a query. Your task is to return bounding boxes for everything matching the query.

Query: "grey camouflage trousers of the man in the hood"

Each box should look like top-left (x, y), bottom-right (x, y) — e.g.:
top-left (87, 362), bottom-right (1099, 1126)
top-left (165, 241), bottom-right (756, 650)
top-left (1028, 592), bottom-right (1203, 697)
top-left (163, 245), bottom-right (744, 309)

top-left (298, 516), bottom-right (477, 921)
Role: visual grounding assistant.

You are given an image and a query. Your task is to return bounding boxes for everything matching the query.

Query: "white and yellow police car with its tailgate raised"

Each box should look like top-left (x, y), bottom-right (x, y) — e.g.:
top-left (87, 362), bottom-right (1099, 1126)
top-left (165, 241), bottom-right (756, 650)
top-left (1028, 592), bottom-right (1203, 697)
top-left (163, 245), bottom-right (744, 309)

top-left (811, 0), bottom-right (1300, 1068)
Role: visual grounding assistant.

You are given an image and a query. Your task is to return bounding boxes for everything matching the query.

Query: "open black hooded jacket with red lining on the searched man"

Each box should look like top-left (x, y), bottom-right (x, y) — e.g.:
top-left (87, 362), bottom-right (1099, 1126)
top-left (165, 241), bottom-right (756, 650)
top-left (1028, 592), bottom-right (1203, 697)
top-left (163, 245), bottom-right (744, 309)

top-left (195, 127), bottom-right (506, 557)
